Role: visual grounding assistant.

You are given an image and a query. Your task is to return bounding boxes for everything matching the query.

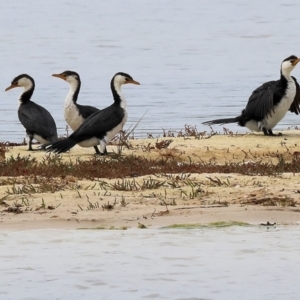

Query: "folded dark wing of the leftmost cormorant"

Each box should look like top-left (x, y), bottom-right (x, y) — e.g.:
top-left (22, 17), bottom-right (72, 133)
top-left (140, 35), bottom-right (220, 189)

top-left (18, 101), bottom-right (57, 139)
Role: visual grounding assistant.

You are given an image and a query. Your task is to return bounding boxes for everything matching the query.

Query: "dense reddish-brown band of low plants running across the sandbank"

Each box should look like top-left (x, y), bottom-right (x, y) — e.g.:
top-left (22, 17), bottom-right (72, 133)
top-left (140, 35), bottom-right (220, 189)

top-left (0, 154), bottom-right (300, 179)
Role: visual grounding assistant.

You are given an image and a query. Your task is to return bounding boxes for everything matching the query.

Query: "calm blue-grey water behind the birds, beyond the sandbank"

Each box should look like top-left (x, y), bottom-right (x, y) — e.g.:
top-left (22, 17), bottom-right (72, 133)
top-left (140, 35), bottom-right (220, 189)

top-left (0, 0), bottom-right (300, 142)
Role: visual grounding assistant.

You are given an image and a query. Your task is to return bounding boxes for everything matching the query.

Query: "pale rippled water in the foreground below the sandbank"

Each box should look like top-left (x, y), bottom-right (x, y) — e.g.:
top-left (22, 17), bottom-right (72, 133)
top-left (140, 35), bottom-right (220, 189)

top-left (0, 226), bottom-right (300, 300)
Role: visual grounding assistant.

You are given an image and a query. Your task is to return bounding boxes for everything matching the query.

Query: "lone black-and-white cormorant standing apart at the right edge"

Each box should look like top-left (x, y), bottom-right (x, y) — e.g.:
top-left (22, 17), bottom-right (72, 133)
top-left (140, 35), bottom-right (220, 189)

top-left (203, 55), bottom-right (300, 135)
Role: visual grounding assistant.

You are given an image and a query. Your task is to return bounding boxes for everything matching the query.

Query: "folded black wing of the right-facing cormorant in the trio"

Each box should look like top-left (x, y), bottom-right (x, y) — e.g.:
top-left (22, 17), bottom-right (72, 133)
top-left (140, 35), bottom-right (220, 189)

top-left (70, 104), bottom-right (125, 142)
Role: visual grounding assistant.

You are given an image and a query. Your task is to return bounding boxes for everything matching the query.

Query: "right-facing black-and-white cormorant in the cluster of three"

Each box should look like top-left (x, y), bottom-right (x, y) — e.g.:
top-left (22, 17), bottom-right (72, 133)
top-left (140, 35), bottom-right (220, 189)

top-left (46, 72), bottom-right (140, 155)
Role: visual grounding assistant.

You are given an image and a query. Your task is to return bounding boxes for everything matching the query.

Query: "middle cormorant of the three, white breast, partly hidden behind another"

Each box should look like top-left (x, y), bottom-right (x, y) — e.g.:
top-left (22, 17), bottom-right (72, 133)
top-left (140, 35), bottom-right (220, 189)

top-left (52, 71), bottom-right (102, 154)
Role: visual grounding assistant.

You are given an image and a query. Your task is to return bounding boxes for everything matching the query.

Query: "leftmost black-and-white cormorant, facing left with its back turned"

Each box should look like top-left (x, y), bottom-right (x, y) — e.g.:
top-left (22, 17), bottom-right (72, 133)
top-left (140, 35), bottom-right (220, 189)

top-left (5, 74), bottom-right (58, 151)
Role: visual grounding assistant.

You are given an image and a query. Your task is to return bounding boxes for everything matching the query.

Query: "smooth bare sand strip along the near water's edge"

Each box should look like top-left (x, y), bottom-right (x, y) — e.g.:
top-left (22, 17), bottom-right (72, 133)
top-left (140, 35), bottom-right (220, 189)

top-left (0, 205), bottom-right (300, 231)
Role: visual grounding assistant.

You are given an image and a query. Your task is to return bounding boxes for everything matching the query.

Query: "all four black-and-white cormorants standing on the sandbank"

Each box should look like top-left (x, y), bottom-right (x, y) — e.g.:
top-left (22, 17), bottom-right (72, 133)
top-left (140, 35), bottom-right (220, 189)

top-left (5, 55), bottom-right (300, 155)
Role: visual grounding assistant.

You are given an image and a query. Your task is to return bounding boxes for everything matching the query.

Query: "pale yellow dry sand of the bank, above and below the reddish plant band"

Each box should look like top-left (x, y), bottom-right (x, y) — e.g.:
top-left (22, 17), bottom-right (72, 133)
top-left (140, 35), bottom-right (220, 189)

top-left (0, 130), bottom-right (300, 230)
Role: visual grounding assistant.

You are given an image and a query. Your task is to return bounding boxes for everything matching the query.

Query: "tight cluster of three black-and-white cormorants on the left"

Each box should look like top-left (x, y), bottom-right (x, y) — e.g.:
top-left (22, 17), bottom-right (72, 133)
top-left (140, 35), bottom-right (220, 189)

top-left (5, 71), bottom-right (140, 155)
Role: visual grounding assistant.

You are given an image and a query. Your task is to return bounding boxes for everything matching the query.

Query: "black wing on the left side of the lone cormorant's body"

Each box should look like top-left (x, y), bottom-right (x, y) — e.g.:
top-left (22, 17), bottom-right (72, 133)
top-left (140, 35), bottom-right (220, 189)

top-left (243, 81), bottom-right (281, 120)
